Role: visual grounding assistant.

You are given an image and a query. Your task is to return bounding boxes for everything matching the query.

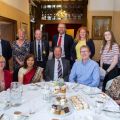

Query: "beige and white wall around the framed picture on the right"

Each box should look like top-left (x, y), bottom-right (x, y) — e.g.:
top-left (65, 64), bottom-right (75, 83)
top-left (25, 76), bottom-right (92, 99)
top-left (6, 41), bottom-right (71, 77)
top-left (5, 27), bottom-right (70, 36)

top-left (87, 0), bottom-right (120, 60)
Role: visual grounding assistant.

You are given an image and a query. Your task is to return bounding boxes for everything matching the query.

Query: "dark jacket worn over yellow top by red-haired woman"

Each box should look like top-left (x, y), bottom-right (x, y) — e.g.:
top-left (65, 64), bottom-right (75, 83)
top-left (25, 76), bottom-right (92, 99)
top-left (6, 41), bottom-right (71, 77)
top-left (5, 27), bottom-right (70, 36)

top-left (71, 39), bottom-right (95, 61)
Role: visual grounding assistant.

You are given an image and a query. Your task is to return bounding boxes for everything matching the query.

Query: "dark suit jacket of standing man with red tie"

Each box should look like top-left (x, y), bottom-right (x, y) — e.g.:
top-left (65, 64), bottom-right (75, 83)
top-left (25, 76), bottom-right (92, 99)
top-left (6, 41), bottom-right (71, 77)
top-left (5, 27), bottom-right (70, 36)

top-left (52, 34), bottom-right (73, 60)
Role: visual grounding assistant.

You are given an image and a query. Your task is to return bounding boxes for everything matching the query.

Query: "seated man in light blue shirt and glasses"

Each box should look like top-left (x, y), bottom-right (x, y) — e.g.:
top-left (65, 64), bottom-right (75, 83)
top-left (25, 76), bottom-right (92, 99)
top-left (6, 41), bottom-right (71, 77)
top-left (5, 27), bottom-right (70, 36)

top-left (69, 45), bottom-right (100, 87)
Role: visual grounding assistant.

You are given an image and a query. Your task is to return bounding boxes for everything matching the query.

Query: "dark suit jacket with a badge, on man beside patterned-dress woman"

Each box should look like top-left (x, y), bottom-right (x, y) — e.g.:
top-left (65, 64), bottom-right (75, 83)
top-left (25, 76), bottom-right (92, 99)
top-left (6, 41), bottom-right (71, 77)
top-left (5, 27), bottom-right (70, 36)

top-left (30, 40), bottom-right (49, 62)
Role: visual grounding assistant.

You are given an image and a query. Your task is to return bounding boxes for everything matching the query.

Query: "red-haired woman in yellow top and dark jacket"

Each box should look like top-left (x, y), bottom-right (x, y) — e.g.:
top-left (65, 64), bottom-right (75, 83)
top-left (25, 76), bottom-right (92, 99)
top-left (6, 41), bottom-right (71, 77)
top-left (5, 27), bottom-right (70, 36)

top-left (71, 27), bottom-right (95, 61)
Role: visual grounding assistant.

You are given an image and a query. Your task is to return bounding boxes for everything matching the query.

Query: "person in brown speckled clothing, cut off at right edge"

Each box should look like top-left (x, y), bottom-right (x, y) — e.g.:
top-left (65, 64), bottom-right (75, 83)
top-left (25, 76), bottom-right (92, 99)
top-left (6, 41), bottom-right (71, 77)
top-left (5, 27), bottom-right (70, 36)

top-left (106, 76), bottom-right (120, 105)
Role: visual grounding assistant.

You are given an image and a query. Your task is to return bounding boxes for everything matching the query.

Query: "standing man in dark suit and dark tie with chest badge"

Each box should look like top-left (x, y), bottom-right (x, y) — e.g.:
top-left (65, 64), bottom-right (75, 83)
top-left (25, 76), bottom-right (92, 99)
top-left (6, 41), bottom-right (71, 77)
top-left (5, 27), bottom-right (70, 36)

top-left (30, 29), bottom-right (49, 68)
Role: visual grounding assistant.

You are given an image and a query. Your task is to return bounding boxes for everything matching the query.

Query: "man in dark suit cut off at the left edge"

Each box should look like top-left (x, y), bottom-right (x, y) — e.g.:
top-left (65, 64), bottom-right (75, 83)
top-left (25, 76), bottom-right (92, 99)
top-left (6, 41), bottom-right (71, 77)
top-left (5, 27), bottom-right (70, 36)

top-left (0, 31), bottom-right (12, 69)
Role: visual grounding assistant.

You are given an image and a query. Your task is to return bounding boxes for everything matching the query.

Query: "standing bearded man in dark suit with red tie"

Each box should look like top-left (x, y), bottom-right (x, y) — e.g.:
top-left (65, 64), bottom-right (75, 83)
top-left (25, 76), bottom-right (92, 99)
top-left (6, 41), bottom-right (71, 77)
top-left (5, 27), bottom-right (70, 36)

top-left (52, 23), bottom-right (73, 60)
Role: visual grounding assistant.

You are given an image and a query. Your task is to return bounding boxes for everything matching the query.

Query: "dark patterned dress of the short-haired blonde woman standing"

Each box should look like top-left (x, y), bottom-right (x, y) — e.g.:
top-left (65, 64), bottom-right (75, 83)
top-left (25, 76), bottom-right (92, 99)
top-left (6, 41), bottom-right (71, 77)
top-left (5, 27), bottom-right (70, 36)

top-left (12, 41), bottom-right (30, 69)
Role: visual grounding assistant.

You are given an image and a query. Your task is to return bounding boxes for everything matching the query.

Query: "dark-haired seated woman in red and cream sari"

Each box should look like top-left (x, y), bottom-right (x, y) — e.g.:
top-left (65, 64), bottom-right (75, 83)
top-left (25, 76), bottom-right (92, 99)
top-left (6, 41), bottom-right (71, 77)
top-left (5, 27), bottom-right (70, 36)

top-left (18, 54), bottom-right (43, 84)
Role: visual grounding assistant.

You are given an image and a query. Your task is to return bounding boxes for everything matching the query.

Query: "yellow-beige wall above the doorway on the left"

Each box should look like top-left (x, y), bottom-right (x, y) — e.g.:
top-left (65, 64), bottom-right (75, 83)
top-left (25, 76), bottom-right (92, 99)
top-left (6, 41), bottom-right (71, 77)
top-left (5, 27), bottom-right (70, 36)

top-left (0, 0), bottom-right (30, 39)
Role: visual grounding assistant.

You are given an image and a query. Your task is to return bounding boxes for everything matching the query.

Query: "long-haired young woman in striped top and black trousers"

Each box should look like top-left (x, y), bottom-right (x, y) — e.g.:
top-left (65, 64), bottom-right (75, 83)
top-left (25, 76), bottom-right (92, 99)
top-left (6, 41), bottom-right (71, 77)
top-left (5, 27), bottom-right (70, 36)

top-left (100, 30), bottom-right (119, 92)
